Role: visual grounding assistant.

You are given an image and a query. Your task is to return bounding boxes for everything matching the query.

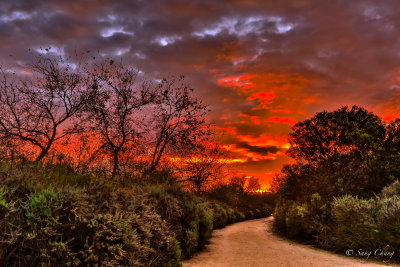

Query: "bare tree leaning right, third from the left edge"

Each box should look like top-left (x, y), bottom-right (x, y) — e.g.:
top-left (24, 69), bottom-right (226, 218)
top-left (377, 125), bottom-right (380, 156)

top-left (149, 76), bottom-right (209, 172)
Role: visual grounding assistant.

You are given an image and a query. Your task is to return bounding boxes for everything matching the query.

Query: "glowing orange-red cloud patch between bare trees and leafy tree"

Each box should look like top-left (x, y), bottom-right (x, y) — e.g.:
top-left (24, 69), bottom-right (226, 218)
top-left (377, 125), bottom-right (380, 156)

top-left (217, 72), bottom-right (314, 184)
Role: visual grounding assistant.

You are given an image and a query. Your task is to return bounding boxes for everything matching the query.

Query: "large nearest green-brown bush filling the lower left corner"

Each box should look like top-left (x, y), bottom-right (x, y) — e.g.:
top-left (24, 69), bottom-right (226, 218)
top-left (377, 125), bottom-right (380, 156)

top-left (0, 165), bottom-right (180, 266)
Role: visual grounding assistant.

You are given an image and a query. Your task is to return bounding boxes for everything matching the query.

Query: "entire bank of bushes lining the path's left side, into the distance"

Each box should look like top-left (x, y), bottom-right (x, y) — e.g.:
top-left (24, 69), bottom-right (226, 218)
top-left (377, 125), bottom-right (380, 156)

top-left (0, 162), bottom-right (272, 266)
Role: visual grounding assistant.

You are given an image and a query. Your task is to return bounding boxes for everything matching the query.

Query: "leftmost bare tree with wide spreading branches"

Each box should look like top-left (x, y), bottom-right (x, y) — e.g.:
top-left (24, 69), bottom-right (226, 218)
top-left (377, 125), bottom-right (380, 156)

top-left (0, 55), bottom-right (91, 161)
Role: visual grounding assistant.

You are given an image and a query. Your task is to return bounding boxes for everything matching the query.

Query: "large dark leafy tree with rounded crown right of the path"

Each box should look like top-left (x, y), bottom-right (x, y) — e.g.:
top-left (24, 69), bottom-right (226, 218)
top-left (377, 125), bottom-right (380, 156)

top-left (273, 106), bottom-right (394, 199)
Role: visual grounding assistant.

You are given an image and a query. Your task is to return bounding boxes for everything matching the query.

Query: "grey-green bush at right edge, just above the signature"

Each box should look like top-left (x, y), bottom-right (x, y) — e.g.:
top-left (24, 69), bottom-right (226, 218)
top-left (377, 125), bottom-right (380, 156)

top-left (321, 181), bottom-right (400, 259)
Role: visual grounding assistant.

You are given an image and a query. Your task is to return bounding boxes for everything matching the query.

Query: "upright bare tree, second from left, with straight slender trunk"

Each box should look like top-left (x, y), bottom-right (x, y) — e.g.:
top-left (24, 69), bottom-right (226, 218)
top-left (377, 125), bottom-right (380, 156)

top-left (86, 60), bottom-right (154, 177)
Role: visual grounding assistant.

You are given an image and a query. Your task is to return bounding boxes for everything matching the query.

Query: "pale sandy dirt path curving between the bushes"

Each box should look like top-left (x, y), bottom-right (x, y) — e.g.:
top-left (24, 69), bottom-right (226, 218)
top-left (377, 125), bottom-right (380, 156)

top-left (183, 217), bottom-right (396, 267)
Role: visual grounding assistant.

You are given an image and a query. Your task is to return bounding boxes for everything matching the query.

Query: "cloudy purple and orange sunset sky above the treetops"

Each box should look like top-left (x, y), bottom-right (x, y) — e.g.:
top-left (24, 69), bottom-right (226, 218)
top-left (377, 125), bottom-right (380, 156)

top-left (0, 0), bottom-right (400, 187)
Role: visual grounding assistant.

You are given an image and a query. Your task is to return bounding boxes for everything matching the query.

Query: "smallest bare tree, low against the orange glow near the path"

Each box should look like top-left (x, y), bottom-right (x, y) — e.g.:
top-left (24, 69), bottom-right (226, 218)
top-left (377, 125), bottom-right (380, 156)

top-left (180, 144), bottom-right (225, 194)
